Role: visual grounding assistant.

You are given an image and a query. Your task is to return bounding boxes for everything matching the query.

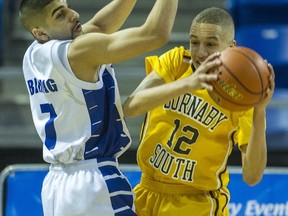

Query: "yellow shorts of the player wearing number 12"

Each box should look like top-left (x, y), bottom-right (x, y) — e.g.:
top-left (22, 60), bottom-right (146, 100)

top-left (134, 176), bottom-right (230, 216)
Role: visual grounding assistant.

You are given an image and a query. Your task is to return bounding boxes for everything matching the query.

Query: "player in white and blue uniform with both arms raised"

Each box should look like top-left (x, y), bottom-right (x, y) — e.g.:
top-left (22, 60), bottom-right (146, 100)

top-left (20, 0), bottom-right (178, 216)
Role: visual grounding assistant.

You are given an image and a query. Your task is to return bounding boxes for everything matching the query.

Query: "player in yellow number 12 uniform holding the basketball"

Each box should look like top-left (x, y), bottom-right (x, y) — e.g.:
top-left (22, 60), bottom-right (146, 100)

top-left (124, 8), bottom-right (274, 216)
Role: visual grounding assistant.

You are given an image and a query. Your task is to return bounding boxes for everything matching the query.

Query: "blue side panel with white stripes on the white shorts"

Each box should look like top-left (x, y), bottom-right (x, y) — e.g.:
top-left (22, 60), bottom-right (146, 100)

top-left (98, 160), bottom-right (136, 216)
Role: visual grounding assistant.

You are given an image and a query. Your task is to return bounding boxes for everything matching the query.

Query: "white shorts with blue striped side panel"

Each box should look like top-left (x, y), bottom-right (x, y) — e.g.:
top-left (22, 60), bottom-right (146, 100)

top-left (41, 158), bottom-right (136, 216)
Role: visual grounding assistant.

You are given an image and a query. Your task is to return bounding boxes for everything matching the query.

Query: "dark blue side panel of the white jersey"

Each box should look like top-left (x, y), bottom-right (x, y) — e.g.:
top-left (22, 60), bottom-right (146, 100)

top-left (83, 69), bottom-right (130, 159)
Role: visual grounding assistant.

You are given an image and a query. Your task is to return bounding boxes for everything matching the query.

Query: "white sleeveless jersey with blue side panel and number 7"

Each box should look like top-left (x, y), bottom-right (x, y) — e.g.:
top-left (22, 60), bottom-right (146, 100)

top-left (23, 40), bottom-right (131, 164)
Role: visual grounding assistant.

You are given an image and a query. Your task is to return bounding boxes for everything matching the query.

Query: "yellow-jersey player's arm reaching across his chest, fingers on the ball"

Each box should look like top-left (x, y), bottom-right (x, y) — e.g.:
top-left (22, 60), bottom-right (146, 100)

top-left (123, 53), bottom-right (221, 117)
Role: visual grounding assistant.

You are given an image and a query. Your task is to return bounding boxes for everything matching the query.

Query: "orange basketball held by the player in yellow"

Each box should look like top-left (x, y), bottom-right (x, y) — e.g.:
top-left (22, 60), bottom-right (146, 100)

top-left (209, 47), bottom-right (269, 111)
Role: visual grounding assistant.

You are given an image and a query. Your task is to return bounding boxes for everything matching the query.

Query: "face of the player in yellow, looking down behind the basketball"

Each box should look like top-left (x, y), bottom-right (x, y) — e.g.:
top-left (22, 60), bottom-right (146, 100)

top-left (190, 23), bottom-right (230, 68)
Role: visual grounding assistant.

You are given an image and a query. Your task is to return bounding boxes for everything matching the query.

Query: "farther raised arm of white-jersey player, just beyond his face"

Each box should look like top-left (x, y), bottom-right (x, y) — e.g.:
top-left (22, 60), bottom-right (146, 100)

top-left (83, 0), bottom-right (136, 34)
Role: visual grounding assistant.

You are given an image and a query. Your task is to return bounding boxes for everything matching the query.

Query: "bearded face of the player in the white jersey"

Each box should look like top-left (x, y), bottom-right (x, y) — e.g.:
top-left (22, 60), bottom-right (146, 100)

top-left (40, 0), bottom-right (82, 40)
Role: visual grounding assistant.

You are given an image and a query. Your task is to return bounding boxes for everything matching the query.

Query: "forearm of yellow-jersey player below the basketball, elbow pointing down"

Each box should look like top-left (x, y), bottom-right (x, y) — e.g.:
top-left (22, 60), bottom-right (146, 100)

top-left (243, 109), bottom-right (267, 185)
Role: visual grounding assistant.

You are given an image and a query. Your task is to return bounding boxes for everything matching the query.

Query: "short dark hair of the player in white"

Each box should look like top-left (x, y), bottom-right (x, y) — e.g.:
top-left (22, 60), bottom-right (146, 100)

top-left (19, 0), bottom-right (53, 31)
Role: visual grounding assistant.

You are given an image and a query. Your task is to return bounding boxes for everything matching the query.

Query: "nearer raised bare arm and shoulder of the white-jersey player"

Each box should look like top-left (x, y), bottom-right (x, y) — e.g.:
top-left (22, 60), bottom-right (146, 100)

top-left (68, 0), bottom-right (178, 81)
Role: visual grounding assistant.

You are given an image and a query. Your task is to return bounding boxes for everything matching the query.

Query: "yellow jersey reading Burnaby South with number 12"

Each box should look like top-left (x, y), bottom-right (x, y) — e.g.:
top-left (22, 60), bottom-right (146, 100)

top-left (137, 47), bottom-right (253, 191)
